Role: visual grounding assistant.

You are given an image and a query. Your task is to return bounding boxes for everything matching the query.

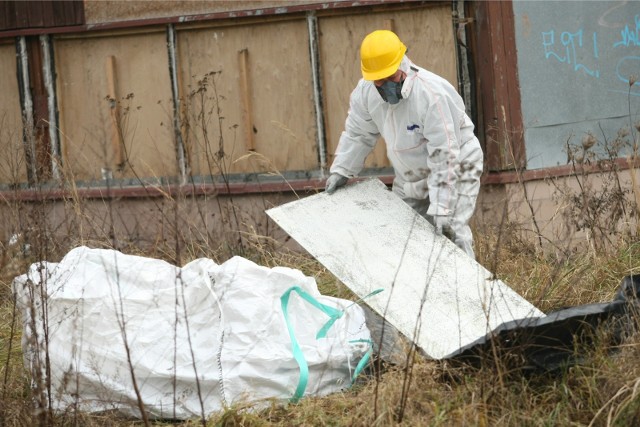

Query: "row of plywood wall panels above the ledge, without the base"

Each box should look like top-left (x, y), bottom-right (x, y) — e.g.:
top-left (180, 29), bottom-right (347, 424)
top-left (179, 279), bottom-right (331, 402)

top-left (0, 2), bottom-right (457, 187)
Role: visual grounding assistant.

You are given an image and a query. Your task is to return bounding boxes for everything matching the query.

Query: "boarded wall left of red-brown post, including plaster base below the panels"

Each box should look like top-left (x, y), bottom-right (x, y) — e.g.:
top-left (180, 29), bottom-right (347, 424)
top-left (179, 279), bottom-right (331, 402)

top-left (0, 2), bottom-right (458, 254)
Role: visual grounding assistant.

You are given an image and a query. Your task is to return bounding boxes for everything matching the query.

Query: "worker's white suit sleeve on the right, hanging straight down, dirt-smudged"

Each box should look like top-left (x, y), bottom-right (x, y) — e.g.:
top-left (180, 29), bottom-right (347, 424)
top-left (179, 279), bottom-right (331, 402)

top-left (423, 91), bottom-right (460, 216)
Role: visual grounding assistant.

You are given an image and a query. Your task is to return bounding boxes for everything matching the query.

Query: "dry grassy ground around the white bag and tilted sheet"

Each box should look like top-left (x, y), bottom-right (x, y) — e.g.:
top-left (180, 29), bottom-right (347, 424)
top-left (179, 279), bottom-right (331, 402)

top-left (0, 221), bottom-right (640, 426)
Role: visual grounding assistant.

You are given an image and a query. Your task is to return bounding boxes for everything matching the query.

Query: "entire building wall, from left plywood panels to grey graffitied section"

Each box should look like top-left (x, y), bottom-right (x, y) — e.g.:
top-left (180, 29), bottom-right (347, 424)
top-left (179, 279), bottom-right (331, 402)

top-left (0, 1), bottom-right (640, 258)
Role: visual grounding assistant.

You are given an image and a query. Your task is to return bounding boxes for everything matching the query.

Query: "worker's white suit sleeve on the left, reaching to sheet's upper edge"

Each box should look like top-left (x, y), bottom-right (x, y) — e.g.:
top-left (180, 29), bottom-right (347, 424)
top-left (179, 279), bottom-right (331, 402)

top-left (330, 82), bottom-right (380, 177)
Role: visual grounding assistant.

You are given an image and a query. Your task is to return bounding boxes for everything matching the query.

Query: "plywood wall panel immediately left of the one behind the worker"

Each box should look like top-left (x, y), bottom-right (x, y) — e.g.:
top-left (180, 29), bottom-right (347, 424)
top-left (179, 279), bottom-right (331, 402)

top-left (177, 18), bottom-right (318, 175)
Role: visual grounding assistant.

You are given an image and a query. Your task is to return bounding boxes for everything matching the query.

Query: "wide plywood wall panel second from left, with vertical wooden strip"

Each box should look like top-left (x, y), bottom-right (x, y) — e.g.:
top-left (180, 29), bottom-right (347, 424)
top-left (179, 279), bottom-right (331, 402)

top-left (54, 29), bottom-right (178, 180)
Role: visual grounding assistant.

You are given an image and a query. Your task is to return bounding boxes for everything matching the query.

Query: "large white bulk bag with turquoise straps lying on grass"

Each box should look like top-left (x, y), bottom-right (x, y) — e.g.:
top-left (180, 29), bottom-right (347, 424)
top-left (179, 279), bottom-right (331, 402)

top-left (13, 247), bottom-right (370, 419)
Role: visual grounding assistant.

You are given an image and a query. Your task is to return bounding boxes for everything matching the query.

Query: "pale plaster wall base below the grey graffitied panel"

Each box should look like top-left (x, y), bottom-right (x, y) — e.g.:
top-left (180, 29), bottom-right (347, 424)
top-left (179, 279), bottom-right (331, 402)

top-left (473, 163), bottom-right (640, 258)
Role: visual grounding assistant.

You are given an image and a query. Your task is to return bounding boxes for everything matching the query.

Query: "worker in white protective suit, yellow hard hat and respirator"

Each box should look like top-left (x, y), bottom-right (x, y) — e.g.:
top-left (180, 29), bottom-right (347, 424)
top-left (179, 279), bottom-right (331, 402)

top-left (325, 30), bottom-right (483, 259)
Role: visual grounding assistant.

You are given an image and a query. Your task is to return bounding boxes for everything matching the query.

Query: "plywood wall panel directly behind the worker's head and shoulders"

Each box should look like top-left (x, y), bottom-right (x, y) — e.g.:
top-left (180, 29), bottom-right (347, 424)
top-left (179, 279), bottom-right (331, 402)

top-left (318, 4), bottom-right (458, 171)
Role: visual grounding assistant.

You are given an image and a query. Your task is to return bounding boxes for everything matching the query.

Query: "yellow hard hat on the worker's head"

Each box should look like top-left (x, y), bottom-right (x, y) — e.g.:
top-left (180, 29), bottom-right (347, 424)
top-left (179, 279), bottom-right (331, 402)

top-left (360, 30), bottom-right (407, 80)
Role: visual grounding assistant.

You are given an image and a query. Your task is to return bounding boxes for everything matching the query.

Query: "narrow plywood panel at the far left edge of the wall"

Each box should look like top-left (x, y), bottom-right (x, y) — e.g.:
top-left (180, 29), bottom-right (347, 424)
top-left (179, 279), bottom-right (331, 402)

top-left (0, 44), bottom-right (27, 184)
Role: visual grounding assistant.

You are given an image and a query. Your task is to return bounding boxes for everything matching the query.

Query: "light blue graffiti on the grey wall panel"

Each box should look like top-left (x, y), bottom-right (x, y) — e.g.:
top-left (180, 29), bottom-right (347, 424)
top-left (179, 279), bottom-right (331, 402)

top-left (542, 15), bottom-right (640, 96)
